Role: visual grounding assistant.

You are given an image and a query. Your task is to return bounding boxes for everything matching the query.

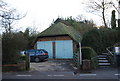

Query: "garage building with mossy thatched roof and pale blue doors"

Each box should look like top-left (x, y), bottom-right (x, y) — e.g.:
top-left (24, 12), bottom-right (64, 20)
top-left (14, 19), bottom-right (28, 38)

top-left (34, 22), bottom-right (80, 59)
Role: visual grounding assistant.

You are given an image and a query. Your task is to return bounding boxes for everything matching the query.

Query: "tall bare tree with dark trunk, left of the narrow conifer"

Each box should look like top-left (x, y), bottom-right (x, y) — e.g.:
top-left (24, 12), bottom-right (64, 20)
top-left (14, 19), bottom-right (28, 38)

top-left (87, 0), bottom-right (112, 27)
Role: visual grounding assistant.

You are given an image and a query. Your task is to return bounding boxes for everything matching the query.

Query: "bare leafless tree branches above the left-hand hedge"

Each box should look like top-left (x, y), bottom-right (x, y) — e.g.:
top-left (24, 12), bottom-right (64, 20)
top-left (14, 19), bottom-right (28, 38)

top-left (0, 0), bottom-right (25, 33)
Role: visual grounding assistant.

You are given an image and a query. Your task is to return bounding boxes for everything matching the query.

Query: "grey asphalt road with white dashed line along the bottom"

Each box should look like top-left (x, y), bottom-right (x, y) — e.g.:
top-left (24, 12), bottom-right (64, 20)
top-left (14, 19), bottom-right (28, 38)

top-left (2, 70), bottom-right (120, 80)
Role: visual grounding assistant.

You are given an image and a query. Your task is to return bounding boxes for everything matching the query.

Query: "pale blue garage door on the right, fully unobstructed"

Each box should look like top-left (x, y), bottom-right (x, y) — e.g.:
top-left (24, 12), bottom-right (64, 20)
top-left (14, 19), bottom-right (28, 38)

top-left (56, 40), bottom-right (73, 59)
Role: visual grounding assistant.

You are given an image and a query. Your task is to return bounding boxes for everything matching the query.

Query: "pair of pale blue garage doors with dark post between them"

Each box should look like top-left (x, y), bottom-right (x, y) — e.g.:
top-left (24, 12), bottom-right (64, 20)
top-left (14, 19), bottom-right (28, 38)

top-left (37, 40), bottom-right (73, 59)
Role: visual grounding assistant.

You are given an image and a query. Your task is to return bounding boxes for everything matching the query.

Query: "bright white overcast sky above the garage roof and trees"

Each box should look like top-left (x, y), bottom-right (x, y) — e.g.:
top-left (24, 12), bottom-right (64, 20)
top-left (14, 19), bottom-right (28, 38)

top-left (1, 0), bottom-right (118, 32)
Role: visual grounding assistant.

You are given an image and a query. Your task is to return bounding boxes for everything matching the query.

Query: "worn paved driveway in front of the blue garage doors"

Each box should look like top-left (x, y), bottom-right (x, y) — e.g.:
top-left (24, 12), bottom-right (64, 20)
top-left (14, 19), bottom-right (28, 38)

top-left (30, 60), bottom-right (74, 72)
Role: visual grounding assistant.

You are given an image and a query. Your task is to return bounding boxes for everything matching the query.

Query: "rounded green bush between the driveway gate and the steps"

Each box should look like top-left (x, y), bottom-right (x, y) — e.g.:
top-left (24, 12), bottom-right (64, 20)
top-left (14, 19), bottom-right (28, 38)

top-left (82, 47), bottom-right (98, 69)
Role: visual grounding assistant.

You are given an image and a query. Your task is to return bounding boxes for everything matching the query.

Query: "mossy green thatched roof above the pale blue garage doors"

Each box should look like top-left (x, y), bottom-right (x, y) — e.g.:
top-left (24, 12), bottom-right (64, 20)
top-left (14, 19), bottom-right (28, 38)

top-left (38, 22), bottom-right (81, 42)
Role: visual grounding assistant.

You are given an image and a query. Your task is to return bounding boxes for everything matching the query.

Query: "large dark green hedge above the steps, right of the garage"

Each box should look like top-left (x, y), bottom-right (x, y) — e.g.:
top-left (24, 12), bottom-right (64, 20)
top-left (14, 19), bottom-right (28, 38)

top-left (82, 28), bottom-right (119, 54)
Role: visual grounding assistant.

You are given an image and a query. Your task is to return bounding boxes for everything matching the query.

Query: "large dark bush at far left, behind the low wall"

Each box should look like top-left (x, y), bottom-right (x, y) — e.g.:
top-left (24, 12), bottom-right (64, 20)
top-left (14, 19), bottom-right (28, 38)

top-left (2, 33), bottom-right (27, 64)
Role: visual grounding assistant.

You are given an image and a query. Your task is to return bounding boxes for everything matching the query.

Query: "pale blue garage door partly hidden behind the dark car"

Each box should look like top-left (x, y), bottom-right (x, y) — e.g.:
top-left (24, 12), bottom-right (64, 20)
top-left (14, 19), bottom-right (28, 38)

top-left (37, 41), bottom-right (53, 58)
